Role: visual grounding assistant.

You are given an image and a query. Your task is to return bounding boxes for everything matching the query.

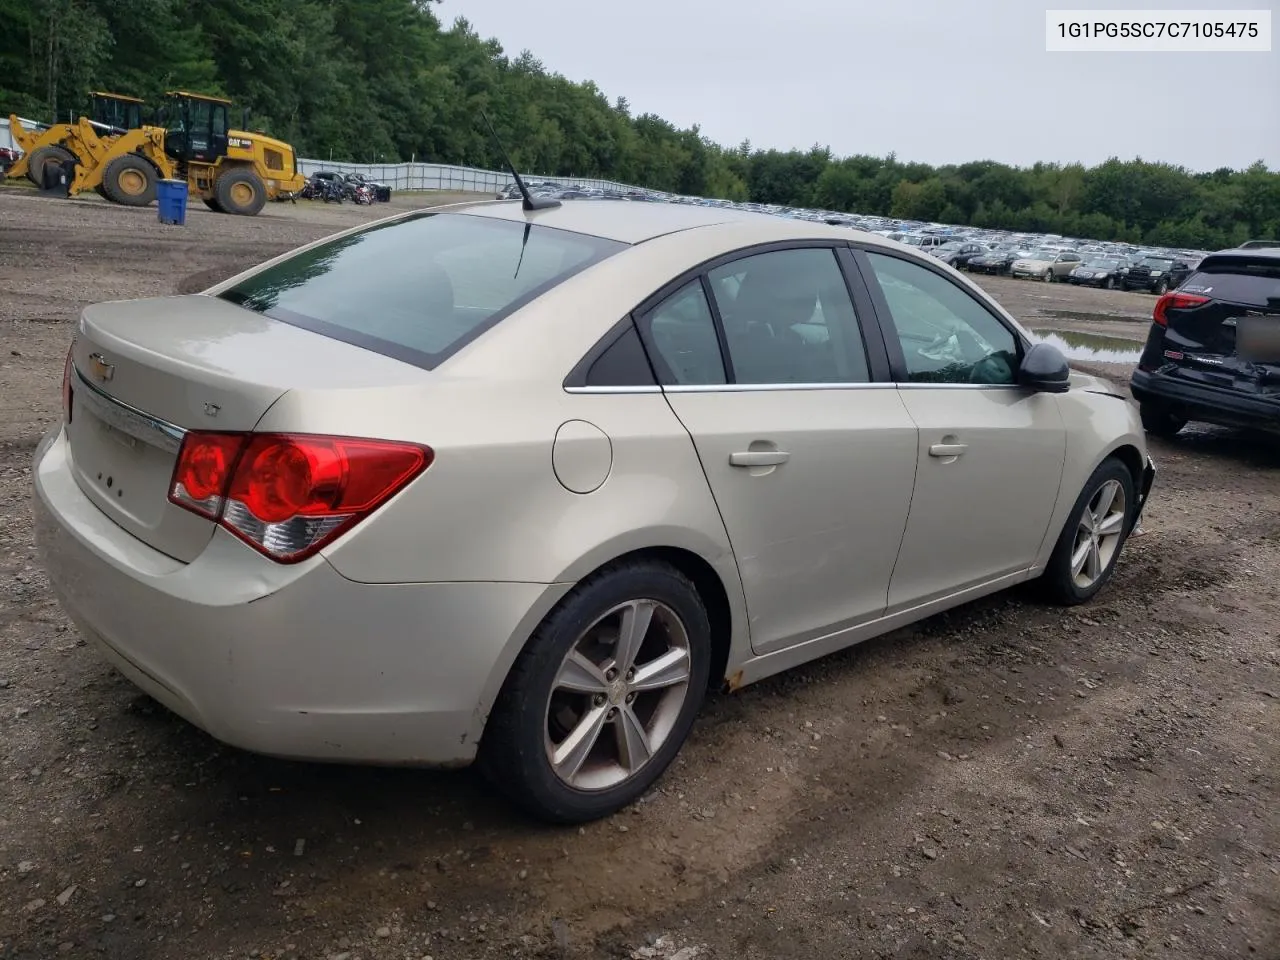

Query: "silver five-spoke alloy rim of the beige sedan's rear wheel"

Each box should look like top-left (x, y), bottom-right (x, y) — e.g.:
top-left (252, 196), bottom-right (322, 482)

top-left (544, 599), bottom-right (692, 790)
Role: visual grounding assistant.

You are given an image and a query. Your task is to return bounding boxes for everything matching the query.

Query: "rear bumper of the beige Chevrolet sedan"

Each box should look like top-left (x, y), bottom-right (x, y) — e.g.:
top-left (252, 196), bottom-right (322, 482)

top-left (32, 429), bottom-right (567, 765)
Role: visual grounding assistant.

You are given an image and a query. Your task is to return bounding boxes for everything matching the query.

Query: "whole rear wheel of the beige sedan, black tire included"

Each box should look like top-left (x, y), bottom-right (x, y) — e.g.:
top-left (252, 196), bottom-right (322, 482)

top-left (477, 561), bottom-right (712, 823)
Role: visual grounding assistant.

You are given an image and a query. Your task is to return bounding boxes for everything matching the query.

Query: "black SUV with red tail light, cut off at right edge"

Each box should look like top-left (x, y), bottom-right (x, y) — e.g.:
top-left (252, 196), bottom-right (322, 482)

top-left (1130, 247), bottom-right (1280, 436)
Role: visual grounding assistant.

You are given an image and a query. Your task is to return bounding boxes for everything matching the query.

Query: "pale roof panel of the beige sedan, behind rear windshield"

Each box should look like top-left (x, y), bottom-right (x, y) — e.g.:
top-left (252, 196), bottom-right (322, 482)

top-left (466, 200), bottom-right (849, 243)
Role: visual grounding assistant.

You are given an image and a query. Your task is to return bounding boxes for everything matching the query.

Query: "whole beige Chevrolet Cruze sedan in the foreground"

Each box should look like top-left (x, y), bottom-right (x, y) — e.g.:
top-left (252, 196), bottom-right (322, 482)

top-left (32, 201), bottom-right (1155, 823)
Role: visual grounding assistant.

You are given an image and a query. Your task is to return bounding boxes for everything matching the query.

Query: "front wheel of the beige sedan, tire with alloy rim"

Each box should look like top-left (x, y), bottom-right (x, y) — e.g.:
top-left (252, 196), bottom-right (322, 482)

top-left (1039, 457), bottom-right (1137, 607)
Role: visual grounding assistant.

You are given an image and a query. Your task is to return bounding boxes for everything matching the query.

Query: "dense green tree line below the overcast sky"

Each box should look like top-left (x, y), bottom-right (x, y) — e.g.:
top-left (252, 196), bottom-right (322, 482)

top-left (0, 0), bottom-right (1280, 248)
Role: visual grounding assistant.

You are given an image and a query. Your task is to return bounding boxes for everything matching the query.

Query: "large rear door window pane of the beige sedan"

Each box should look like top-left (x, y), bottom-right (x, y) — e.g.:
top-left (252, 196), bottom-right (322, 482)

top-left (708, 247), bottom-right (870, 384)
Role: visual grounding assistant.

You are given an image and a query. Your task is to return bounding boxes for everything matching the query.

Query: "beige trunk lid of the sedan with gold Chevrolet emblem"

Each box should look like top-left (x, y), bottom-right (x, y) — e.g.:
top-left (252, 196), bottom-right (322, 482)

top-left (67, 296), bottom-right (429, 562)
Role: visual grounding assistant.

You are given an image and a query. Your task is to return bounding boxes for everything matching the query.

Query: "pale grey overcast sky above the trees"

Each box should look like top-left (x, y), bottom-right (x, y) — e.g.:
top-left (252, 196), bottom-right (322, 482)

top-left (436, 0), bottom-right (1280, 170)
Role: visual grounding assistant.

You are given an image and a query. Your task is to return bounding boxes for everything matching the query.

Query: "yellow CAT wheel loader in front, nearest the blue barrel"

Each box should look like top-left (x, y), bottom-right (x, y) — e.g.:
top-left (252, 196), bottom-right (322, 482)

top-left (10, 90), bottom-right (306, 216)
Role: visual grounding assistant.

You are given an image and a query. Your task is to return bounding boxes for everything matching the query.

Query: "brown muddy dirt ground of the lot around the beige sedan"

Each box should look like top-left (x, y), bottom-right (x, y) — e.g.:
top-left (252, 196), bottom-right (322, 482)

top-left (0, 191), bottom-right (1280, 960)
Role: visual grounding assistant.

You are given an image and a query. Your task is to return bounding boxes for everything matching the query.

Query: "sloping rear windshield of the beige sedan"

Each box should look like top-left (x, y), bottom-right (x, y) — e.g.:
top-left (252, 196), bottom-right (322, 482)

top-left (220, 214), bottom-right (626, 370)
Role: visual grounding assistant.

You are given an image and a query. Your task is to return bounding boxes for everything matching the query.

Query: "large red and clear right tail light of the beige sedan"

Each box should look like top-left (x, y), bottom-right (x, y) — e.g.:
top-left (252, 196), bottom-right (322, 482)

top-left (169, 431), bottom-right (434, 563)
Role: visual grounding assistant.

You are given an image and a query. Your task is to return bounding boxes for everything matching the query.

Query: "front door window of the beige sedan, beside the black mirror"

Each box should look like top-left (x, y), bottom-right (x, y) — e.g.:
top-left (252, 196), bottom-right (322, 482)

top-left (867, 252), bottom-right (1018, 384)
